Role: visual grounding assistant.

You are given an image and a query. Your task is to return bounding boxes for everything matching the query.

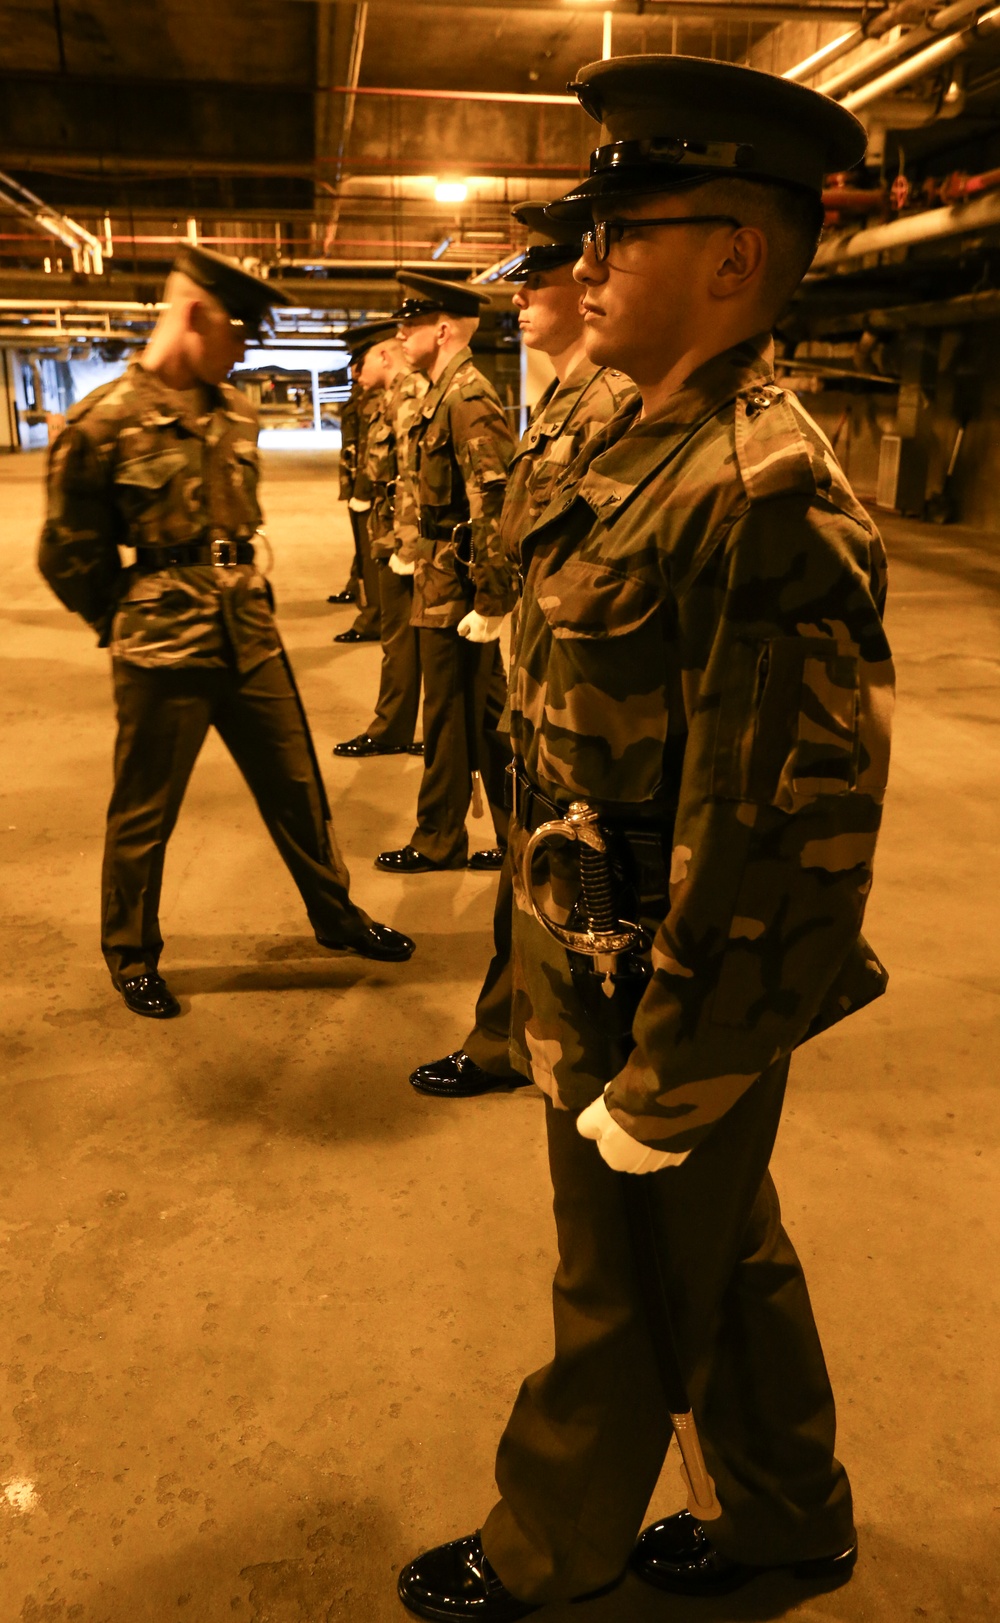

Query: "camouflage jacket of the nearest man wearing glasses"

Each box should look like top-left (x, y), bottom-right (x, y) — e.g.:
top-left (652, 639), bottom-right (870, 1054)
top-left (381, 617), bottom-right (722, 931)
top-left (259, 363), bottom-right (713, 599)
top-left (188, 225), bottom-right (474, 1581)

top-left (510, 338), bottom-right (893, 1151)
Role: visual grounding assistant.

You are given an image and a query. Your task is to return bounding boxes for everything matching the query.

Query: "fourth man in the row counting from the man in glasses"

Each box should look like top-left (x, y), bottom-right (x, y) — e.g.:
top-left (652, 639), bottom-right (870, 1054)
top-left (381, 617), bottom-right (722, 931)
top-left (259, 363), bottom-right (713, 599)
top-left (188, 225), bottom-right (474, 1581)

top-left (333, 320), bottom-right (429, 756)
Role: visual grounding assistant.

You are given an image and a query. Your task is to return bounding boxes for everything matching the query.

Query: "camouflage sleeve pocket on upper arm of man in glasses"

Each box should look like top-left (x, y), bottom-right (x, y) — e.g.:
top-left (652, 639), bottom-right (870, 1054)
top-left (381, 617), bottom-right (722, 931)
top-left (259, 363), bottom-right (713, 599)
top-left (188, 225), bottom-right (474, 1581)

top-left (711, 636), bottom-right (860, 812)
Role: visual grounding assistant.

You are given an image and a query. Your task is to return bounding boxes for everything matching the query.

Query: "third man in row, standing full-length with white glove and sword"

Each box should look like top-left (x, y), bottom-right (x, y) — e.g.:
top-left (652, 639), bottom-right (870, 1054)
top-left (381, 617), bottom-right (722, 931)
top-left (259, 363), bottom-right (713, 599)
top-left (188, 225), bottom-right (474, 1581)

top-left (375, 273), bottom-right (516, 873)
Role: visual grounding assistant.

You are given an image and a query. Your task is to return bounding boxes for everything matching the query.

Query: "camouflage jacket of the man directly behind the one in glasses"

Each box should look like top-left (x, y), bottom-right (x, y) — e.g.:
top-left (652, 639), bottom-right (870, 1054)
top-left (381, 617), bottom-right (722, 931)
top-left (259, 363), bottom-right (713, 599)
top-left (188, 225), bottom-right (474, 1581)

top-left (500, 360), bottom-right (635, 558)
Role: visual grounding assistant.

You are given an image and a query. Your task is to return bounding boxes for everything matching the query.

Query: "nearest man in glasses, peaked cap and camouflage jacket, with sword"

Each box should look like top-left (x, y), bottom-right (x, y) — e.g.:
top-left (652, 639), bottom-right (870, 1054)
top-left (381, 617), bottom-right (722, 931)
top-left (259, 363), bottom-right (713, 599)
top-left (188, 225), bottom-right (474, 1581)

top-left (399, 57), bottom-right (893, 1623)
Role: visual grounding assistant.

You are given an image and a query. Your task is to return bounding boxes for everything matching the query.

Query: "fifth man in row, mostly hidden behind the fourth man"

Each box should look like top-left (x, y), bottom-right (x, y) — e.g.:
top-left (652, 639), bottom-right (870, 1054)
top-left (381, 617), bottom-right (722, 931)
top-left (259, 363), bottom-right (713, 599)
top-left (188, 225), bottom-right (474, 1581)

top-left (326, 335), bottom-right (391, 643)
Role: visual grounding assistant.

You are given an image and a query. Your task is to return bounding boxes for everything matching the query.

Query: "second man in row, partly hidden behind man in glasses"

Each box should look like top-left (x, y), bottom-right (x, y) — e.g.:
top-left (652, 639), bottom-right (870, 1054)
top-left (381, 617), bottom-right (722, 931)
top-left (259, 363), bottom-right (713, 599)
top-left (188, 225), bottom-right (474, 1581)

top-left (409, 203), bottom-right (635, 1099)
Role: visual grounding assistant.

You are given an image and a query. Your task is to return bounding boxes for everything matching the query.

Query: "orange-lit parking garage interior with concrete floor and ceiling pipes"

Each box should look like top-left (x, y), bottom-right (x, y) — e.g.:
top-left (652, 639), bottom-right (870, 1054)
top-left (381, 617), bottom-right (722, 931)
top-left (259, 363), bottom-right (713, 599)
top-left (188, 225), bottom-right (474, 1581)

top-left (0, 9), bottom-right (1000, 1623)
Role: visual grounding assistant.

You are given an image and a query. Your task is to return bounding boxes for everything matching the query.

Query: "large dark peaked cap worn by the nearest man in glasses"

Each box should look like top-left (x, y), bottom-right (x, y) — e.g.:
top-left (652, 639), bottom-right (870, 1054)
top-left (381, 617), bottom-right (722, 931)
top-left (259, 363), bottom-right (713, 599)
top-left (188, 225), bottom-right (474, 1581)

top-left (550, 55), bottom-right (867, 219)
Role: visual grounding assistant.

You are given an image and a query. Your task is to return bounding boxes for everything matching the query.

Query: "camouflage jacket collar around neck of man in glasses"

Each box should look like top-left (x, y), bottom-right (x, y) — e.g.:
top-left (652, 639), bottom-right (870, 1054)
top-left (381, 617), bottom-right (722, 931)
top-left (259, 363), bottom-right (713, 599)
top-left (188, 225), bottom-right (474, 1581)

top-left (573, 333), bottom-right (774, 524)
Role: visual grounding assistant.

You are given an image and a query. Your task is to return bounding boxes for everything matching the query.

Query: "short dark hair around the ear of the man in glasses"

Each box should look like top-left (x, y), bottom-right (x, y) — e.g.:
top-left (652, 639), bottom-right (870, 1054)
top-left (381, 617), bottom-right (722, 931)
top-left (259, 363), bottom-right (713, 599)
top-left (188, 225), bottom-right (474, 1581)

top-left (693, 177), bottom-right (823, 325)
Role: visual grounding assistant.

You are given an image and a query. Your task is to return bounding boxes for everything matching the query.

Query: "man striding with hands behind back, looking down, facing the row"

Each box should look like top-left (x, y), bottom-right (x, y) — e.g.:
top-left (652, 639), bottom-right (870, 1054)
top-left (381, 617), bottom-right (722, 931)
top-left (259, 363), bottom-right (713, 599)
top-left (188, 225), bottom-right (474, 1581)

top-left (39, 248), bottom-right (412, 1019)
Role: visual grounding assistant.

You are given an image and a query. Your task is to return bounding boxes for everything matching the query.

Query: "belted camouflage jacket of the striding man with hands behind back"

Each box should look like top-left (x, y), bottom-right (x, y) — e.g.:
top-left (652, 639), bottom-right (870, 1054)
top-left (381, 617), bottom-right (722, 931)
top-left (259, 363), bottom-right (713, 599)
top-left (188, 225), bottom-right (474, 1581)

top-left (39, 360), bottom-right (281, 670)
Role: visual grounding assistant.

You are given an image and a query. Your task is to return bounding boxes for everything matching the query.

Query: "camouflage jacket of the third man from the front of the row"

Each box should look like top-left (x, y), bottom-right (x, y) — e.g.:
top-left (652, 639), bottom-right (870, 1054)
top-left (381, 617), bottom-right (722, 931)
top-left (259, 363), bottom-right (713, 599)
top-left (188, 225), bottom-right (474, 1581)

top-left (407, 349), bottom-right (516, 628)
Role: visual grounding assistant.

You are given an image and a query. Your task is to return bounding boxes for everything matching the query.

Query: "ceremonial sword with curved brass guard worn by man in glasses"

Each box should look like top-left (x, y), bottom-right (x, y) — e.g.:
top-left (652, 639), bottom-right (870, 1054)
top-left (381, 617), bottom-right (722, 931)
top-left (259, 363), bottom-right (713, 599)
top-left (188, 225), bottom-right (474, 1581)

top-left (521, 800), bottom-right (722, 1522)
